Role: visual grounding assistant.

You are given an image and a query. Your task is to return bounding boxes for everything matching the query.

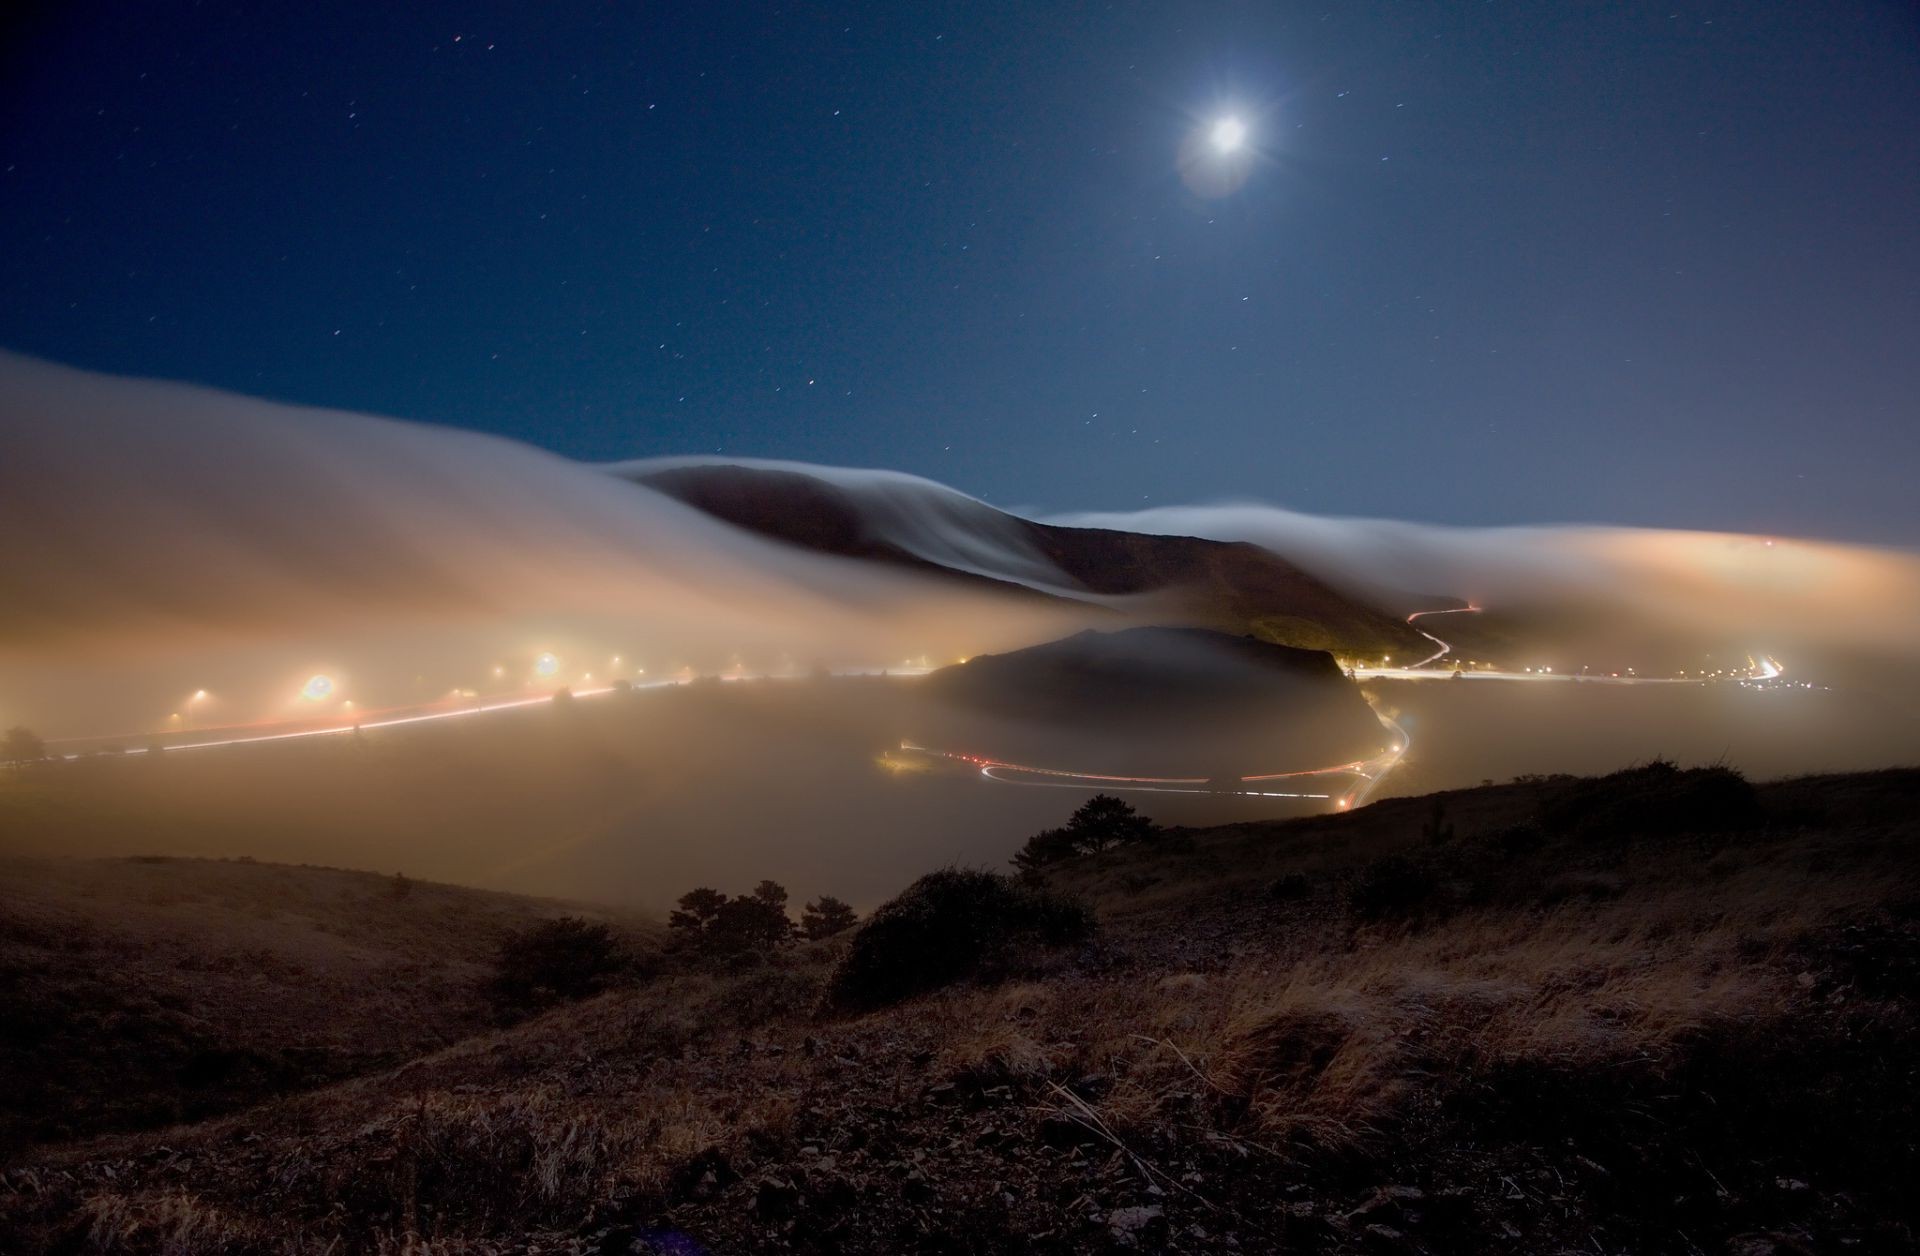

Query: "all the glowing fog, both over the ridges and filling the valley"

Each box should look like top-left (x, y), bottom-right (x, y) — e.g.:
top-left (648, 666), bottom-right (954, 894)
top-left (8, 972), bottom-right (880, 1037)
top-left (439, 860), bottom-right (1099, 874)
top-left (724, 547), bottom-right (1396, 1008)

top-left (0, 355), bottom-right (1920, 906)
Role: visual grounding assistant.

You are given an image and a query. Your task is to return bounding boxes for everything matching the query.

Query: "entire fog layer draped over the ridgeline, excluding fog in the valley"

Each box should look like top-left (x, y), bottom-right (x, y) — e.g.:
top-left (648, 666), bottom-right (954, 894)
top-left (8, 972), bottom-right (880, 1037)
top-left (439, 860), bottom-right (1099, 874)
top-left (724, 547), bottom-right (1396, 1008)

top-left (0, 353), bottom-right (1920, 736)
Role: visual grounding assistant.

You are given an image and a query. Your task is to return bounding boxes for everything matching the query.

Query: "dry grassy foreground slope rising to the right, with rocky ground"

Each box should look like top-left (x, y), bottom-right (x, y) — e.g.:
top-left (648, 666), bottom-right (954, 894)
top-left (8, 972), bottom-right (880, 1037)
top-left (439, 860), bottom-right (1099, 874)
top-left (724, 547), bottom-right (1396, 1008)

top-left (0, 764), bottom-right (1920, 1254)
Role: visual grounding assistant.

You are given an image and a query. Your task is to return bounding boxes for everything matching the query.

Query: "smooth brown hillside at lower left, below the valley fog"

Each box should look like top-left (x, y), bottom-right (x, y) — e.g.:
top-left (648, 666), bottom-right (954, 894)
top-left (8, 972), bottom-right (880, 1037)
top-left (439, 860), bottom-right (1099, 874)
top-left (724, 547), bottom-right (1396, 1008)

top-left (0, 857), bottom-right (657, 1156)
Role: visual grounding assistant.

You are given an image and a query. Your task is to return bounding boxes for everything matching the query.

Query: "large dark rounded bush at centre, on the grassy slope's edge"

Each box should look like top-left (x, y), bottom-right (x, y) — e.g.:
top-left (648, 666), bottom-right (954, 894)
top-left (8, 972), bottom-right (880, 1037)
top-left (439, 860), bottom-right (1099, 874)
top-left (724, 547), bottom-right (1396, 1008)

top-left (829, 868), bottom-right (1094, 1010)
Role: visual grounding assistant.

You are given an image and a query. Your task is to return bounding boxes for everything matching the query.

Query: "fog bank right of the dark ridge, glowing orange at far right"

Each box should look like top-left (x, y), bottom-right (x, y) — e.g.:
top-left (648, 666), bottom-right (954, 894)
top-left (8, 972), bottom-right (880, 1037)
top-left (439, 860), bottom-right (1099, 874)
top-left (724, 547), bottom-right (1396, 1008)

top-left (1048, 505), bottom-right (1920, 711)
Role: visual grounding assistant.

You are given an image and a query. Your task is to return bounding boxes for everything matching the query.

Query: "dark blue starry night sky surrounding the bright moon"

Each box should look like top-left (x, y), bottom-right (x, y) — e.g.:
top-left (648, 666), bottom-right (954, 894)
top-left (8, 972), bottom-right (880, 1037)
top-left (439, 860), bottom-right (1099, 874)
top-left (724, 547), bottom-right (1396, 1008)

top-left (0, 0), bottom-right (1920, 543)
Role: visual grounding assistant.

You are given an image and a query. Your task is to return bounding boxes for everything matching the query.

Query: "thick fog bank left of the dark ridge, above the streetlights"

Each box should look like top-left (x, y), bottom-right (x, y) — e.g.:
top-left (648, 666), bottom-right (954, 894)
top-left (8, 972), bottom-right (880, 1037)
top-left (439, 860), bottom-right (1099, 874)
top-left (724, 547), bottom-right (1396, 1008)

top-left (0, 355), bottom-right (1094, 737)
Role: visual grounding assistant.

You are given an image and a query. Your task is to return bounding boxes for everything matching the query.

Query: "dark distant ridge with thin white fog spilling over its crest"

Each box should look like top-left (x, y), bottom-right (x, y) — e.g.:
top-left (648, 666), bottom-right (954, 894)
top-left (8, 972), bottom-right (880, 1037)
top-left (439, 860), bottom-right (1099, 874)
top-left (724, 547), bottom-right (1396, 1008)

top-left (612, 459), bottom-right (1446, 655)
